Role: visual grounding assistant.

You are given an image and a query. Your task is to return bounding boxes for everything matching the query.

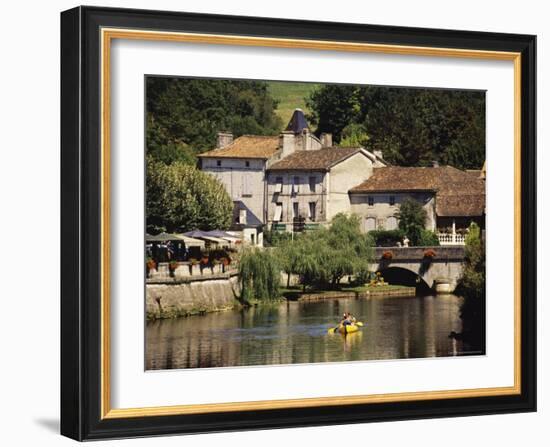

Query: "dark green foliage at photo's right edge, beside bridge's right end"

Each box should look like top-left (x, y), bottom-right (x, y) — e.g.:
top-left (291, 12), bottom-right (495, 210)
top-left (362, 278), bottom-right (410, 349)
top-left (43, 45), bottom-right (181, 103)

top-left (459, 222), bottom-right (485, 298)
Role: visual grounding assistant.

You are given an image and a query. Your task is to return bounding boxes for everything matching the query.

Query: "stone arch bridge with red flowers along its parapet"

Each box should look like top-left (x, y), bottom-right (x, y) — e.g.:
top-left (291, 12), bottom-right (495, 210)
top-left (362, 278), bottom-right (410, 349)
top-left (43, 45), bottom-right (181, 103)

top-left (371, 246), bottom-right (465, 293)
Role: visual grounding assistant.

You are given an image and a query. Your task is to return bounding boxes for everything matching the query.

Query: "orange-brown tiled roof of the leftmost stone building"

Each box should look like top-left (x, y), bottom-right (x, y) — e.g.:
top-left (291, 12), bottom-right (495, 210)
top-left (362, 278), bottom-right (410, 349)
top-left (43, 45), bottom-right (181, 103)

top-left (199, 135), bottom-right (279, 159)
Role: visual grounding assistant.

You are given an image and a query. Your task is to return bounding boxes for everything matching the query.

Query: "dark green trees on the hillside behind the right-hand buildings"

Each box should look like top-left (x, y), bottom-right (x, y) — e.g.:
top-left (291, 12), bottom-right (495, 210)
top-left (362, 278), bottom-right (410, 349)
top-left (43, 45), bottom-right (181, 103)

top-left (308, 85), bottom-right (485, 169)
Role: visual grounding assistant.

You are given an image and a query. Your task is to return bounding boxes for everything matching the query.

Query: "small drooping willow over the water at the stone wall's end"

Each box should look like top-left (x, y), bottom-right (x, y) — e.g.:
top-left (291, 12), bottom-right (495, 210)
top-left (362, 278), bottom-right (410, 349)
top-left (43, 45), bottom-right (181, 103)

top-left (239, 249), bottom-right (281, 301)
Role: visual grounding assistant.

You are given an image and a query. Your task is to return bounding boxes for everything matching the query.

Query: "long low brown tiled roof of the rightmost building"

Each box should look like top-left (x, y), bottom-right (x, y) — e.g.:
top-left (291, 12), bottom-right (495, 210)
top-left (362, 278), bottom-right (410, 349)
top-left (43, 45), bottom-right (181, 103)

top-left (350, 166), bottom-right (485, 216)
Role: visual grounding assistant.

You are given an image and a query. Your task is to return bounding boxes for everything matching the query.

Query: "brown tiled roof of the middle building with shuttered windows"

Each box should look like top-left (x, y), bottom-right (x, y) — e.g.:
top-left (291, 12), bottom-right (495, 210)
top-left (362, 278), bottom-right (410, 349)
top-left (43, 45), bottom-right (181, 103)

top-left (269, 146), bottom-right (361, 171)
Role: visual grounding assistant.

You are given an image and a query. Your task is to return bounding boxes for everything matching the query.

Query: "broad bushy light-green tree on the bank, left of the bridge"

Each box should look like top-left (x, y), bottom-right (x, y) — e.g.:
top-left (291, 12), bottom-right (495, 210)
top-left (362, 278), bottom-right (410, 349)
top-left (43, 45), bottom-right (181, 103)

top-left (276, 214), bottom-right (374, 290)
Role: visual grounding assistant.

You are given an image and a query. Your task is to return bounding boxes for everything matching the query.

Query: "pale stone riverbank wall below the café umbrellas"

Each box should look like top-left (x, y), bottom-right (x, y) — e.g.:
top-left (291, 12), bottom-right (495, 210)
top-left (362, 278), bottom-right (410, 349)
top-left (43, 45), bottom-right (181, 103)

top-left (145, 274), bottom-right (240, 320)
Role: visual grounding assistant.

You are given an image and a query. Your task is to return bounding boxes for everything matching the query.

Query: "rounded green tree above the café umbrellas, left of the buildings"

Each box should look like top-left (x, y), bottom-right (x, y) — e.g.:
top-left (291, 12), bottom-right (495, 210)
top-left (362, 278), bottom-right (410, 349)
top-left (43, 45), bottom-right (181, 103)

top-left (146, 156), bottom-right (233, 233)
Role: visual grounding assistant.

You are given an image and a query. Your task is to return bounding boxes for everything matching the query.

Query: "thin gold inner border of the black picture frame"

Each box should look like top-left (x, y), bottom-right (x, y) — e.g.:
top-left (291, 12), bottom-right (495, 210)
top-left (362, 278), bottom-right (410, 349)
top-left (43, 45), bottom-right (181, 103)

top-left (100, 28), bottom-right (521, 419)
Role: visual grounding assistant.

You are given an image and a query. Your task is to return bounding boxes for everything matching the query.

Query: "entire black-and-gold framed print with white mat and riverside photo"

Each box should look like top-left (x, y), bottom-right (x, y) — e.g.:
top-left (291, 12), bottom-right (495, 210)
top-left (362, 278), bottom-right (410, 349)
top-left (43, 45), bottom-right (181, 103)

top-left (61, 7), bottom-right (536, 440)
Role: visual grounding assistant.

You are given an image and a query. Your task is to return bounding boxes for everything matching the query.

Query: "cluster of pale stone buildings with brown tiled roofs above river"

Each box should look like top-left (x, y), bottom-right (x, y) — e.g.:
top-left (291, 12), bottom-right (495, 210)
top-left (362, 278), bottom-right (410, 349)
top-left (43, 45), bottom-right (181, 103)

top-left (199, 109), bottom-right (486, 245)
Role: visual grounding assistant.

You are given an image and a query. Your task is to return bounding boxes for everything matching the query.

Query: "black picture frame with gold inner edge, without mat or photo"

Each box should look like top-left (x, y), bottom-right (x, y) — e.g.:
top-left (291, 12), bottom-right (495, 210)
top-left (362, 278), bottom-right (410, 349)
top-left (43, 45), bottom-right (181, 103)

top-left (61, 7), bottom-right (537, 440)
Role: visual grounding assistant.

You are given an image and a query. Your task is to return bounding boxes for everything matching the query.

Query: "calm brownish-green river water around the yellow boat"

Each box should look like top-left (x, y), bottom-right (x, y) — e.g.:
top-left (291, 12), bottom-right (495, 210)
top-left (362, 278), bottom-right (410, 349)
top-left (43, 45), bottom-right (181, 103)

top-left (146, 295), bottom-right (481, 370)
